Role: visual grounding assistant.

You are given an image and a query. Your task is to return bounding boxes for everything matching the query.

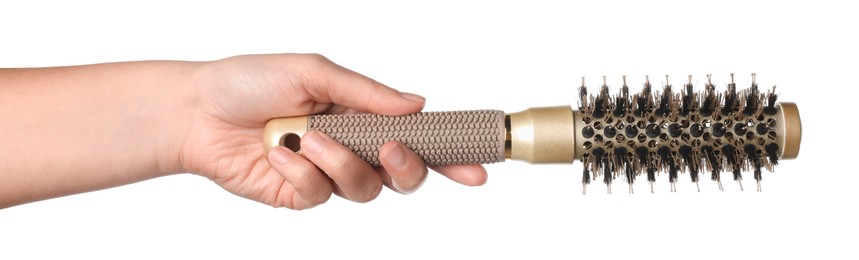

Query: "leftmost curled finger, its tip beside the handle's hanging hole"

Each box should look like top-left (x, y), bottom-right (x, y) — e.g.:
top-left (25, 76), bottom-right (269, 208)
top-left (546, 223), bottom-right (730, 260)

top-left (268, 146), bottom-right (333, 209)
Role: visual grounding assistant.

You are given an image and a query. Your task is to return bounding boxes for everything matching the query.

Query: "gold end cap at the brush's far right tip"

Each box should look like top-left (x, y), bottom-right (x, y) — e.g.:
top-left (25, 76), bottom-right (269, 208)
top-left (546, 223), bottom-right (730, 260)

top-left (775, 102), bottom-right (802, 159)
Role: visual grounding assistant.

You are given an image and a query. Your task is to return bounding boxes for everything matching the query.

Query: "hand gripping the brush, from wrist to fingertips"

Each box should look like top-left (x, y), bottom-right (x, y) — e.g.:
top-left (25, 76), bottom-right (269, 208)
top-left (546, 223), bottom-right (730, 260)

top-left (179, 54), bottom-right (487, 209)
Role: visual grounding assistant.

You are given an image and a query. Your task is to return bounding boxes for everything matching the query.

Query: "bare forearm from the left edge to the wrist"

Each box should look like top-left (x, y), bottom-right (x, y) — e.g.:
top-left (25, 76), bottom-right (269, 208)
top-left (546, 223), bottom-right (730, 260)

top-left (0, 61), bottom-right (197, 208)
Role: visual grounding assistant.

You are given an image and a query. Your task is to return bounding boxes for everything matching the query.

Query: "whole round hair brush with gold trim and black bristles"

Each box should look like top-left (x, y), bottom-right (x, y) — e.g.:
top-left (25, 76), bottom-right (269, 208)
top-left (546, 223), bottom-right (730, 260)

top-left (264, 74), bottom-right (802, 194)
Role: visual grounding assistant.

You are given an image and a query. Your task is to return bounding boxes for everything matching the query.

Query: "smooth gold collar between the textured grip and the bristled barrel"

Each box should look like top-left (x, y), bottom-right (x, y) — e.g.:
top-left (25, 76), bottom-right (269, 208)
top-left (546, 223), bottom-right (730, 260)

top-left (509, 106), bottom-right (576, 163)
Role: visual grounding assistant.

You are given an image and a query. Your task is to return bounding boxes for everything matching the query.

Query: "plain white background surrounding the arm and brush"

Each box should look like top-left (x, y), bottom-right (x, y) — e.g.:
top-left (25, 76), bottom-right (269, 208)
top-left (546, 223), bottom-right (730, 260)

top-left (0, 1), bottom-right (859, 259)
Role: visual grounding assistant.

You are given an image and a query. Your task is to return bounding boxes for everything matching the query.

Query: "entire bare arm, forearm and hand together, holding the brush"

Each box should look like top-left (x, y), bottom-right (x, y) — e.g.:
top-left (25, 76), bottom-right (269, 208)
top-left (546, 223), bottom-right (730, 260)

top-left (0, 54), bottom-right (487, 209)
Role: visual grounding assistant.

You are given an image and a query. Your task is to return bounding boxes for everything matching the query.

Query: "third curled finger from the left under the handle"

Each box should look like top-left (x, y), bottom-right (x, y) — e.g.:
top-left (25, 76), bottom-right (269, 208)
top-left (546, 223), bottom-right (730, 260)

top-left (379, 141), bottom-right (427, 194)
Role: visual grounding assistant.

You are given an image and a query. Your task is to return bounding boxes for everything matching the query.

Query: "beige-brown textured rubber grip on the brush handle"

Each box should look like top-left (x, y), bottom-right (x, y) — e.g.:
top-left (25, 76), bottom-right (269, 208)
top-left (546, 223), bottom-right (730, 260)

top-left (308, 110), bottom-right (506, 166)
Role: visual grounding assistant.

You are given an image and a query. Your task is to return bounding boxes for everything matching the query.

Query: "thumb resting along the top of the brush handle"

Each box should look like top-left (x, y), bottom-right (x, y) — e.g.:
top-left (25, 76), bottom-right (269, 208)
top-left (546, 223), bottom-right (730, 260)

top-left (288, 54), bottom-right (425, 116)
